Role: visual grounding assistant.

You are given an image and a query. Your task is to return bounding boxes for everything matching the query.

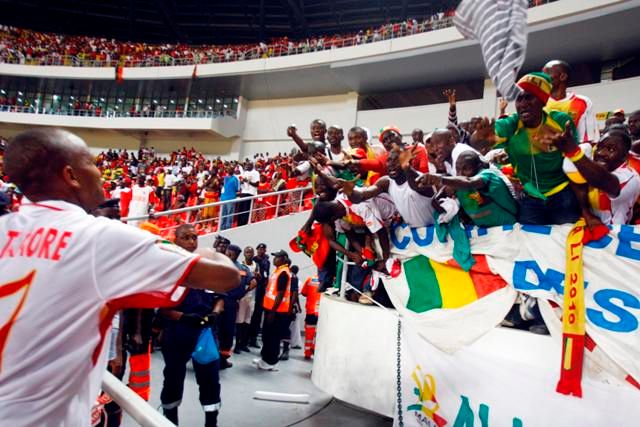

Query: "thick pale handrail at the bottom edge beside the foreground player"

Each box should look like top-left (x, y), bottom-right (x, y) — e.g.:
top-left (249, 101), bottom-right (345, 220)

top-left (102, 371), bottom-right (175, 427)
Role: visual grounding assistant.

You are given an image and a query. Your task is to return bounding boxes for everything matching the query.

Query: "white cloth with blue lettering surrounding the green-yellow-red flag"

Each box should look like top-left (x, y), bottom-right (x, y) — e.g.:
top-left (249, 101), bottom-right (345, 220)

top-left (385, 224), bottom-right (640, 386)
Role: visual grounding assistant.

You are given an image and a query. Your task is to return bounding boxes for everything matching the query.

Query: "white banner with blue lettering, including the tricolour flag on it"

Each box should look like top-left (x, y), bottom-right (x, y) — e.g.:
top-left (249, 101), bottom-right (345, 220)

top-left (384, 224), bottom-right (640, 386)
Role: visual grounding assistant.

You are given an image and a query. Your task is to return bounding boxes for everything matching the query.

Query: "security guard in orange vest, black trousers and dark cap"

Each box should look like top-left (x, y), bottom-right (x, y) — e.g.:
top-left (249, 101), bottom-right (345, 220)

top-left (253, 250), bottom-right (291, 371)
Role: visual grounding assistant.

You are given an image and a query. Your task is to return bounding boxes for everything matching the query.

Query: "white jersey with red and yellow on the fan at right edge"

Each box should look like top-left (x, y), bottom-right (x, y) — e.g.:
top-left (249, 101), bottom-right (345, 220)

top-left (589, 163), bottom-right (640, 225)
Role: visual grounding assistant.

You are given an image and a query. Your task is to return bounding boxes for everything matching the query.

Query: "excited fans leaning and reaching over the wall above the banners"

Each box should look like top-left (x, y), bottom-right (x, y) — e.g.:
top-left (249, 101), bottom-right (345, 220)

top-left (288, 61), bottom-right (640, 322)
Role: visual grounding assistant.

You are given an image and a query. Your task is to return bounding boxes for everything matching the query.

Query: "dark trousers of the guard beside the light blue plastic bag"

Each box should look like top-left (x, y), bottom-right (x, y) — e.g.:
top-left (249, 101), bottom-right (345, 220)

top-left (160, 322), bottom-right (220, 412)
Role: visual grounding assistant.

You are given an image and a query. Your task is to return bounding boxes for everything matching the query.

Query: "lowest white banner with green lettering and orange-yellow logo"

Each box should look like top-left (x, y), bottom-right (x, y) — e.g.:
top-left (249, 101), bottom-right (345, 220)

top-left (394, 321), bottom-right (640, 427)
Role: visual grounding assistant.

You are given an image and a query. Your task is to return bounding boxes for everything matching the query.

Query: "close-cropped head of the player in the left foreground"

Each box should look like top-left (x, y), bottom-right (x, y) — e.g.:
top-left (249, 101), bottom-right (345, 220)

top-left (4, 128), bottom-right (104, 211)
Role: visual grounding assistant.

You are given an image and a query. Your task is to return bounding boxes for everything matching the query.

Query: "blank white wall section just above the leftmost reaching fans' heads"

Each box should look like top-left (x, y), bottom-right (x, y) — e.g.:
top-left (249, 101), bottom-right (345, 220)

top-left (241, 92), bottom-right (358, 157)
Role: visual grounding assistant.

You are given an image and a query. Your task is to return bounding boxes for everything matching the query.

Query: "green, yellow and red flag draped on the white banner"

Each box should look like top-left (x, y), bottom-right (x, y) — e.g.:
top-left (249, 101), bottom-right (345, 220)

top-left (403, 255), bottom-right (507, 313)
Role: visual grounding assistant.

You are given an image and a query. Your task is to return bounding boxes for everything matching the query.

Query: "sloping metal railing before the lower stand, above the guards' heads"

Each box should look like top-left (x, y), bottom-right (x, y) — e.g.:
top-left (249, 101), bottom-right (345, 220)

top-left (122, 186), bottom-right (315, 237)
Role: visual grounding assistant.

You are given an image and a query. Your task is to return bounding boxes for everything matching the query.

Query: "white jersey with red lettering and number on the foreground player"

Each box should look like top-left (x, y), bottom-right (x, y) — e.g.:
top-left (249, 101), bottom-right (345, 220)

top-left (0, 201), bottom-right (198, 427)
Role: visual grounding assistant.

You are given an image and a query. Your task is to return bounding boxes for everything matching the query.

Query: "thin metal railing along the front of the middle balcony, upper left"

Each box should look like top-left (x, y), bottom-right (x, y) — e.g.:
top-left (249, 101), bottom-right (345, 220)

top-left (0, 104), bottom-right (238, 119)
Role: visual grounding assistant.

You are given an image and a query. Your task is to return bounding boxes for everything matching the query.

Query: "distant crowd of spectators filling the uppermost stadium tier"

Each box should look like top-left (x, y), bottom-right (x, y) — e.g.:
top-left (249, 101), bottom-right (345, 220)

top-left (0, 9), bottom-right (454, 66)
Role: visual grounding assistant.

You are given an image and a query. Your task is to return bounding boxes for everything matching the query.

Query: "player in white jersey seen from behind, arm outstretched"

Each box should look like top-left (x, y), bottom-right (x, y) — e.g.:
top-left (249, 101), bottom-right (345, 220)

top-left (0, 129), bottom-right (239, 427)
